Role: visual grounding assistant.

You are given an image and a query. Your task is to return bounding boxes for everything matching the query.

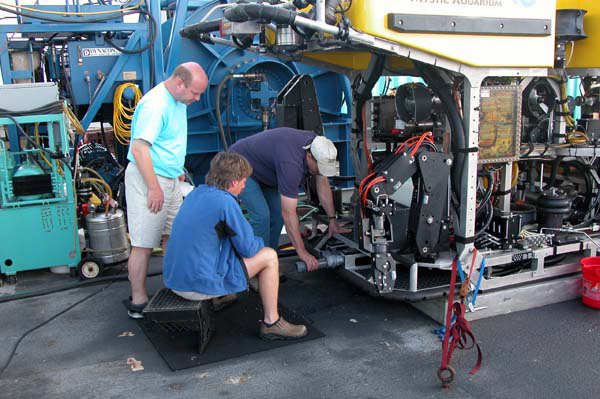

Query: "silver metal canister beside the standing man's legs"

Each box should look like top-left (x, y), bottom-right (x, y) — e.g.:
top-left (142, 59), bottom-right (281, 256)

top-left (85, 209), bottom-right (129, 264)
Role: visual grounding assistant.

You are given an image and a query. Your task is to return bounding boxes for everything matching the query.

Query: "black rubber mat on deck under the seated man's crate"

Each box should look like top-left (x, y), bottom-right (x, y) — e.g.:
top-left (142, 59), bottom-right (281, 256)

top-left (131, 292), bottom-right (325, 371)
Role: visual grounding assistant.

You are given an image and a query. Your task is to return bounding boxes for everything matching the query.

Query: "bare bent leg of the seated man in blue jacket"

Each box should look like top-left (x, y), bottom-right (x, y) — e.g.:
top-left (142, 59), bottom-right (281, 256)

top-left (244, 247), bottom-right (279, 324)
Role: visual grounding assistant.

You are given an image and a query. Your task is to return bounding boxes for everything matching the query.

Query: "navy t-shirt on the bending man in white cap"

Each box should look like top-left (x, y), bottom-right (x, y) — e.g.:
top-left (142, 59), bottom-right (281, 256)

top-left (229, 127), bottom-right (317, 198)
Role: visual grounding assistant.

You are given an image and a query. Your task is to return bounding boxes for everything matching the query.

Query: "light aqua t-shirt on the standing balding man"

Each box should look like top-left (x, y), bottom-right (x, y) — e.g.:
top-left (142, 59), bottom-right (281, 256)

top-left (127, 83), bottom-right (187, 178)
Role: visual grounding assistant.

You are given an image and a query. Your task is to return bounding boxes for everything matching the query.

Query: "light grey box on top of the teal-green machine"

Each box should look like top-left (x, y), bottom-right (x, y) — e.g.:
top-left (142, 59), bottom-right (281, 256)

top-left (0, 83), bottom-right (58, 112)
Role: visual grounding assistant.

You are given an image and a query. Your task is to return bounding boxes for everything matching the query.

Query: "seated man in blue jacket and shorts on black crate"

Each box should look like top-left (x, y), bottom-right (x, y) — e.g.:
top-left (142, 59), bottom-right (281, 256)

top-left (163, 152), bottom-right (308, 340)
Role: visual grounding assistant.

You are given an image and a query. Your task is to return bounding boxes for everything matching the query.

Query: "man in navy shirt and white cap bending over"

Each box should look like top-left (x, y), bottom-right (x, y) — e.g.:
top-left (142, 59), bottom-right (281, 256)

top-left (230, 127), bottom-right (350, 270)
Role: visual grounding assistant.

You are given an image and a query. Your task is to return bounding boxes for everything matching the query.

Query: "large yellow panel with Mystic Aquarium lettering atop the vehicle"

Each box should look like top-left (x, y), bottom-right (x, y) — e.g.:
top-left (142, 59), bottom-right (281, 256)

top-left (348, 0), bottom-right (556, 67)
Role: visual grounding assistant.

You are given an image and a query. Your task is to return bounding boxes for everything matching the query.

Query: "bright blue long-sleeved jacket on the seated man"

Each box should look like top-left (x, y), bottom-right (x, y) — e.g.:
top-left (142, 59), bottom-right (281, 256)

top-left (163, 185), bottom-right (264, 295)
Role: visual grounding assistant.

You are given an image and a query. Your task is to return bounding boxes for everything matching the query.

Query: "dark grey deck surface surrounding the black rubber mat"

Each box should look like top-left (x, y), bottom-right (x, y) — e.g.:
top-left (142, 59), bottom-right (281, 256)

top-left (0, 257), bottom-right (600, 399)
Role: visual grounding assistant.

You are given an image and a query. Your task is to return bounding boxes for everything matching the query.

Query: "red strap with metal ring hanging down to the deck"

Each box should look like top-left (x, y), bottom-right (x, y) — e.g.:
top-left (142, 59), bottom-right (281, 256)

top-left (438, 258), bottom-right (482, 388)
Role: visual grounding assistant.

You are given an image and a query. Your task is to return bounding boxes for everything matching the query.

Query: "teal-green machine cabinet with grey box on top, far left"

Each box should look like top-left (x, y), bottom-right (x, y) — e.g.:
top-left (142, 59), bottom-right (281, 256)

top-left (0, 83), bottom-right (81, 283)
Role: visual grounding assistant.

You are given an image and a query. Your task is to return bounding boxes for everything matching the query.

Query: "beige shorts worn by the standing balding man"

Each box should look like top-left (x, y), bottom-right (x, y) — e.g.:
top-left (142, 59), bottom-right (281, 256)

top-left (125, 162), bottom-right (183, 248)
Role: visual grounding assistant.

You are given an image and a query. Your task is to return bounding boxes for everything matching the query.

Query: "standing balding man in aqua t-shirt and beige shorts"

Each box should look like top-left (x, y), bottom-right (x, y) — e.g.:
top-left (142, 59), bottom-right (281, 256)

top-left (125, 62), bottom-right (208, 318)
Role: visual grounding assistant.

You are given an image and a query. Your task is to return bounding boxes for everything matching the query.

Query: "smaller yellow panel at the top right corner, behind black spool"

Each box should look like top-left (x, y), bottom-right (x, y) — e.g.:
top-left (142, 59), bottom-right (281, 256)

top-left (556, 0), bottom-right (600, 68)
